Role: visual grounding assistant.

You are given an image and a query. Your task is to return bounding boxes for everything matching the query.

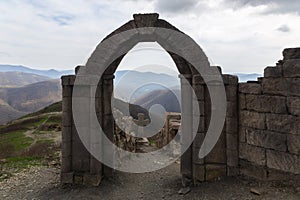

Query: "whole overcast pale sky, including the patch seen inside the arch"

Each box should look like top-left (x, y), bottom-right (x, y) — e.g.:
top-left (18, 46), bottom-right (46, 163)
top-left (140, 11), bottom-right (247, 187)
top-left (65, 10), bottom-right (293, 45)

top-left (0, 0), bottom-right (300, 73)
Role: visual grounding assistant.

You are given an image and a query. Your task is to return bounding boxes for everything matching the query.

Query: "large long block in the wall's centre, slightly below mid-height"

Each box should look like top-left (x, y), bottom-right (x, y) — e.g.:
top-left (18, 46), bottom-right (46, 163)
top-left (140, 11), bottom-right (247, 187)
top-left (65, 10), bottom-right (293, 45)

top-left (246, 129), bottom-right (287, 151)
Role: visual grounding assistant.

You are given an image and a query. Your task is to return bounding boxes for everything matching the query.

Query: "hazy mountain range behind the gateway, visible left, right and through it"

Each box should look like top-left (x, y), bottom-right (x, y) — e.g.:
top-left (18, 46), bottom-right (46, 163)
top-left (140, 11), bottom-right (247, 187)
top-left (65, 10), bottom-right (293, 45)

top-left (0, 65), bottom-right (260, 124)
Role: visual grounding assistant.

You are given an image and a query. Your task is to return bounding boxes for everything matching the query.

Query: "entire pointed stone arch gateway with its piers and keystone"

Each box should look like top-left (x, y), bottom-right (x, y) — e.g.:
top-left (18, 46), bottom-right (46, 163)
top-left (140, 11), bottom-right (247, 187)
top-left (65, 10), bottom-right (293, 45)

top-left (61, 14), bottom-right (238, 185)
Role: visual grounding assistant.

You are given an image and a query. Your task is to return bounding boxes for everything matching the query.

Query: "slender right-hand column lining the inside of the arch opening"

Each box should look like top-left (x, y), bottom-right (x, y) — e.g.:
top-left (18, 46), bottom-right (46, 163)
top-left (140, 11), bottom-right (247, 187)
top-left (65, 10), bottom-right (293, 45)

top-left (179, 74), bottom-right (193, 187)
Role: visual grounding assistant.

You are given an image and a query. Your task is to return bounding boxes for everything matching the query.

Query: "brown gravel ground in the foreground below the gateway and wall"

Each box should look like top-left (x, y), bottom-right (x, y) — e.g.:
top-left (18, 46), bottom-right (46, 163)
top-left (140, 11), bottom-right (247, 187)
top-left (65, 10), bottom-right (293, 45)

top-left (0, 163), bottom-right (300, 200)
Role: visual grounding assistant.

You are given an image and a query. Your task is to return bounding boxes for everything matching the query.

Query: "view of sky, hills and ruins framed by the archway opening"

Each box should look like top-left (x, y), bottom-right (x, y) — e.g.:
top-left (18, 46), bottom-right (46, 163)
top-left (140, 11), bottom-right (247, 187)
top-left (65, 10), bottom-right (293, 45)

top-left (112, 42), bottom-right (181, 173)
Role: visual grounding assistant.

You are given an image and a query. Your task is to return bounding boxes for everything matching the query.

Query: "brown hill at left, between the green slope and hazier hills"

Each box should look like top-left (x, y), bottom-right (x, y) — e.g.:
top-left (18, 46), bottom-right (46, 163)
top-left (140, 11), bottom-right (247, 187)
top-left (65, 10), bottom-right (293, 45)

top-left (0, 80), bottom-right (61, 124)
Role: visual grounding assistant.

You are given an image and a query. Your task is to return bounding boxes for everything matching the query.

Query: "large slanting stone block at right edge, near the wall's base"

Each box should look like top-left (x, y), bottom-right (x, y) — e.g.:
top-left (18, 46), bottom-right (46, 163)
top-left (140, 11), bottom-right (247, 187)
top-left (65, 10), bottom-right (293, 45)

top-left (267, 150), bottom-right (300, 174)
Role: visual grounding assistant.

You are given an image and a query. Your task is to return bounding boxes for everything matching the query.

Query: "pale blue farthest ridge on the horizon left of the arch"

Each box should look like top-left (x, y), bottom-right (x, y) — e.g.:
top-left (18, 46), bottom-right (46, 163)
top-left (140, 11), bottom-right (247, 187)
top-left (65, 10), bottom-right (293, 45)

top-left (0, 65), bottom-right (74, 79)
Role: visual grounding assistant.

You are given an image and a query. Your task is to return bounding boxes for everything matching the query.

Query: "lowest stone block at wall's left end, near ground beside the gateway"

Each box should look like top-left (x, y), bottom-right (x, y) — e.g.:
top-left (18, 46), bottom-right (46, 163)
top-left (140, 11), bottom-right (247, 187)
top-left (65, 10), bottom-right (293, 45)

top-left (240, 160), bottom-right (268, 180)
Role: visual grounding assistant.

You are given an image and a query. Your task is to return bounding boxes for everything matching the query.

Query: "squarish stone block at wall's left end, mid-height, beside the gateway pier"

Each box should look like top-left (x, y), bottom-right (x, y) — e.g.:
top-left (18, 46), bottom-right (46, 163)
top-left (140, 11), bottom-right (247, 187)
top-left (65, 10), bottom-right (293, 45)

top-left (239, 111), bottom-right (266, 129)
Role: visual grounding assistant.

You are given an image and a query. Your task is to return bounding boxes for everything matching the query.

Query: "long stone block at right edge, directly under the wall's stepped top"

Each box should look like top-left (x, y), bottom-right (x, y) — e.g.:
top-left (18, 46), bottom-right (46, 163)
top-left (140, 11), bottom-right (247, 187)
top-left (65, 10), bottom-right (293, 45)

top-left (262, 78), bottom-right (300, 96)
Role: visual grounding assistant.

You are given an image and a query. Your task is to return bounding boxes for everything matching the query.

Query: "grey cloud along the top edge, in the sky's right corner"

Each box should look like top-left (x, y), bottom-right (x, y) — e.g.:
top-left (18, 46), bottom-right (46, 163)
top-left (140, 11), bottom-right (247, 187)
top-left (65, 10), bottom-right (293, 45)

top-left (223, 0), bottom-right (300, 15)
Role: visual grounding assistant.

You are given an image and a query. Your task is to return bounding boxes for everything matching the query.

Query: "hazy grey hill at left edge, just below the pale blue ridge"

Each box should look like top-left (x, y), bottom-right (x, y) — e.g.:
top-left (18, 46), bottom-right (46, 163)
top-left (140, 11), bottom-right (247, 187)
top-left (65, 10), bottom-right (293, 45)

top-left (0, 71), bottom-right (50, 87)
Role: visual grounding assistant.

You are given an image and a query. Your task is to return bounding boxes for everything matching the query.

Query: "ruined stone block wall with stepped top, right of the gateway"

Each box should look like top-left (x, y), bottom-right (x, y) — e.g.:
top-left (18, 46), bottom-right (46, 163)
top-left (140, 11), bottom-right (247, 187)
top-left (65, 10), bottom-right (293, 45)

top-left (239, 48), bottom-right (300, 179)
